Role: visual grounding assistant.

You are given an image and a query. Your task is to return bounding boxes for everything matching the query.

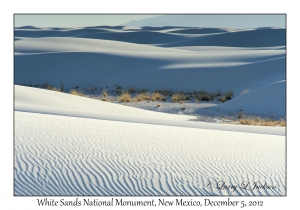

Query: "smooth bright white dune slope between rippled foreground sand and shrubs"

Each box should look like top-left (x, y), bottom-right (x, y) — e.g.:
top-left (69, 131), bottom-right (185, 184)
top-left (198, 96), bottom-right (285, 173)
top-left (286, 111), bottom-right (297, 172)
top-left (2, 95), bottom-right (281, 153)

top-left (15, 85), bottom-right (285, 136)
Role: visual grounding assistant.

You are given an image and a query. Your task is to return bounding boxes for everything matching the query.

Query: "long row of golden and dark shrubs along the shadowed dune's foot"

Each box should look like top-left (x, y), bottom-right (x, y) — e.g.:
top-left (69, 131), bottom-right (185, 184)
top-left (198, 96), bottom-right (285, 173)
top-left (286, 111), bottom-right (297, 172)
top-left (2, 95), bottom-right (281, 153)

top-left (18, 82), bottom-right (237, 104)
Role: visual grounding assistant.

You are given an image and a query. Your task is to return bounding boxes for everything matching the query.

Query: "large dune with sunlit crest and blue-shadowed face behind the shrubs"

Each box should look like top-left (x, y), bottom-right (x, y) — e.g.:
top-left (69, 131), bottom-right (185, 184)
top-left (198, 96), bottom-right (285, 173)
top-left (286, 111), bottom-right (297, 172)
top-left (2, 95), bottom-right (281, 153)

top-left (15, 38), bottom-right (285, 94)
